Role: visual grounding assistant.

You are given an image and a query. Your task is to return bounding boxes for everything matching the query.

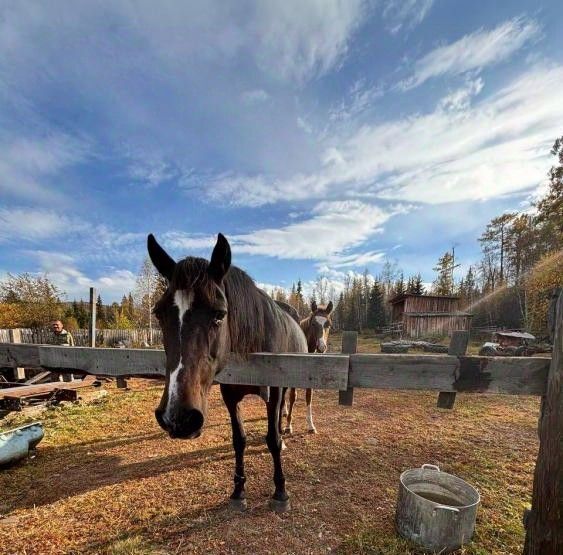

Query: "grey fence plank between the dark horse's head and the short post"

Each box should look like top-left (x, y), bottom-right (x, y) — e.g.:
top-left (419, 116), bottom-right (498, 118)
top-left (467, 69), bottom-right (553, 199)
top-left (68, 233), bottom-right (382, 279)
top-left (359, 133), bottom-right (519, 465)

top-left (215, 353), bottom-right (348, 389)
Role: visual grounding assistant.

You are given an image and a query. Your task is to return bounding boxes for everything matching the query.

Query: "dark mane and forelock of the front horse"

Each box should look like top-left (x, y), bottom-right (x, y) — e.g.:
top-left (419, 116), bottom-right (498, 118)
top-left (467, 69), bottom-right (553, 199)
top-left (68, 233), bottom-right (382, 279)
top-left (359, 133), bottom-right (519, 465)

top-left (171, 256), bottom-right (284, 355)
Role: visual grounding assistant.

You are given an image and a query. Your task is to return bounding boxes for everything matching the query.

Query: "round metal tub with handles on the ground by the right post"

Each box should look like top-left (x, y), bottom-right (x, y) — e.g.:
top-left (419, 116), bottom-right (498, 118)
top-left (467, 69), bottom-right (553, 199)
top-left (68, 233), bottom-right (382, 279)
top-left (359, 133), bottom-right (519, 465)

top-left (395, 464), bottom-right (481, 553)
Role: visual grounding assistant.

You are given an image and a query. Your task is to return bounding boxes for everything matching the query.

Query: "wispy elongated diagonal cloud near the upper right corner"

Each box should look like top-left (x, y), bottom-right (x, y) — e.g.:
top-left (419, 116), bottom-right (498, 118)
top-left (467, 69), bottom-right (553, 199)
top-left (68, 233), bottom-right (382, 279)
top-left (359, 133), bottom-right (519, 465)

top-left (400, 17), bottom-right (540, 90)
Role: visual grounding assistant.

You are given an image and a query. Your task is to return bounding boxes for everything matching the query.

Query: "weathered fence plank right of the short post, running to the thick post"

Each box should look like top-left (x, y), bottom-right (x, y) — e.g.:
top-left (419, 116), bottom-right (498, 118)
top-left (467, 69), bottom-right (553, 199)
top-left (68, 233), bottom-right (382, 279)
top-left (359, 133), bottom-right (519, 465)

top-left (348, 354), bottom-right (549, 395)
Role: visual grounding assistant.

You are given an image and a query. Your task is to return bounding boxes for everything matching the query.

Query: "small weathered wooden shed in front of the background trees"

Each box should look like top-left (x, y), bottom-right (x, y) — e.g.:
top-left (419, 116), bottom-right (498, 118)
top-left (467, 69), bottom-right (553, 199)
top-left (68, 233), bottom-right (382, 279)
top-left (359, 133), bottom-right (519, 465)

top-left (389, 293), bottom-right (472, 337)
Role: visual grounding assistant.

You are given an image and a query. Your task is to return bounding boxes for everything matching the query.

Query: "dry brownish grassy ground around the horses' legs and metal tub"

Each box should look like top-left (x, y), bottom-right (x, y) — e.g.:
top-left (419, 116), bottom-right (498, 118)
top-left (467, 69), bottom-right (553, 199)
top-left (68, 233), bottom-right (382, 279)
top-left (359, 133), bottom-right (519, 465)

top-left (0, 374), bottom-right (539, 555)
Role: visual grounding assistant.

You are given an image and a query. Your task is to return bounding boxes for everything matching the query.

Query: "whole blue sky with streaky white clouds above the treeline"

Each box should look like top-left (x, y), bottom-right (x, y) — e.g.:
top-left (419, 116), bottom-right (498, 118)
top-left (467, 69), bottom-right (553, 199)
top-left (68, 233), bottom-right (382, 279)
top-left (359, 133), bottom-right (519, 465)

top-left (0, 0), bottom-right (563, 301)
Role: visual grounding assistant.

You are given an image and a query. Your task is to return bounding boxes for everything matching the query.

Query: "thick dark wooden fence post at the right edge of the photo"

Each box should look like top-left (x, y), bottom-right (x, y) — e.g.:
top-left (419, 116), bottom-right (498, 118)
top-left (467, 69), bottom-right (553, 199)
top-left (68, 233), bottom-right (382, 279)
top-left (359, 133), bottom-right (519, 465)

top-left (524, 289), bottom-right (563, 555)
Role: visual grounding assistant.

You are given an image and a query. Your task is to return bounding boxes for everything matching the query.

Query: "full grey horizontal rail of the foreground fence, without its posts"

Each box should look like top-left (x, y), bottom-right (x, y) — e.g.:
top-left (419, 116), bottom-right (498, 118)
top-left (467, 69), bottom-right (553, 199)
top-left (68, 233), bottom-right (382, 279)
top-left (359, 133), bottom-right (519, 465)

top-left (0, 343), bottom-right (550, 395)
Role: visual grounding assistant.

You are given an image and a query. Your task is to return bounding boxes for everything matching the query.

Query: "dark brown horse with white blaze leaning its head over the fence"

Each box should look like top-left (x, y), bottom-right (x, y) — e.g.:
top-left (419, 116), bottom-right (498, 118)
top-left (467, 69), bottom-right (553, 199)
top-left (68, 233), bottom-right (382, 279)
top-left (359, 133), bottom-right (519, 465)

top-left (148, 234), bottom-right (307, 511)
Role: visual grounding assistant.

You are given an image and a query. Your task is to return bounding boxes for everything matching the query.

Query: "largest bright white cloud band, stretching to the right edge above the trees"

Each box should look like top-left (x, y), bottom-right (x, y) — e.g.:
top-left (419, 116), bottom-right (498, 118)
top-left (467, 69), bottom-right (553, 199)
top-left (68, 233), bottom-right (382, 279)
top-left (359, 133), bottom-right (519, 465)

top-left (207, 66), bottom-right (563, 206)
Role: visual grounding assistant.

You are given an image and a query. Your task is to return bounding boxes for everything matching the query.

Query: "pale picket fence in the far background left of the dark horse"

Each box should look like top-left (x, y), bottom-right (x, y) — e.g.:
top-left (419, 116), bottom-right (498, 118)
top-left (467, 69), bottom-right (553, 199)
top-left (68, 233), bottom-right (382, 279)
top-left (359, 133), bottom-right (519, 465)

top-left (0, 328), bottom-right (162, 347)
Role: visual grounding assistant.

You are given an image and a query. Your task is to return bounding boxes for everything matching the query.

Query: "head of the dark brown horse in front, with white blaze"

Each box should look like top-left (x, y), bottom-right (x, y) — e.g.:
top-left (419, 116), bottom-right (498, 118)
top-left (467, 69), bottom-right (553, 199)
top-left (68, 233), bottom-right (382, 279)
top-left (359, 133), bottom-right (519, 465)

top-left (147, 234), bottom-right (231, 439)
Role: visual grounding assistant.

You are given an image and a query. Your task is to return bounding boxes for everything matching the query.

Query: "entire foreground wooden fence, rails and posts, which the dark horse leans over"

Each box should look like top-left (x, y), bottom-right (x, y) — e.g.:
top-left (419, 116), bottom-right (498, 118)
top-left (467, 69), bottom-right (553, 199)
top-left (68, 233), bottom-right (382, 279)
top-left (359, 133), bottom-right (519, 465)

top-left (0, 291), bottom-right (563, 555)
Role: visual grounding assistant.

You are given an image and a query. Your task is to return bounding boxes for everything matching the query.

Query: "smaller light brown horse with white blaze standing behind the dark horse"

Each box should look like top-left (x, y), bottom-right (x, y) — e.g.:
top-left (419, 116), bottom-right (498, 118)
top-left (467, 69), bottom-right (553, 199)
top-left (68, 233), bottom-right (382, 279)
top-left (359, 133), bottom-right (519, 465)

top-left (285, 301), bottom-right (333, 434)
